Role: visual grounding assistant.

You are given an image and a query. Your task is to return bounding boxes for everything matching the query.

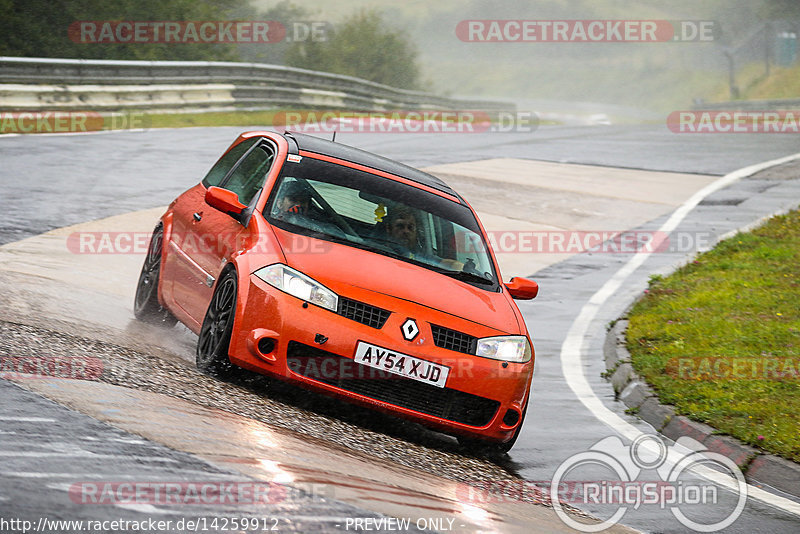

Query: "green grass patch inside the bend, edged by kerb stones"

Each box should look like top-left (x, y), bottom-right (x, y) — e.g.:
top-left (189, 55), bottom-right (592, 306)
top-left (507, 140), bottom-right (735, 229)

top-left (627, 211), bottom-right (800, 461)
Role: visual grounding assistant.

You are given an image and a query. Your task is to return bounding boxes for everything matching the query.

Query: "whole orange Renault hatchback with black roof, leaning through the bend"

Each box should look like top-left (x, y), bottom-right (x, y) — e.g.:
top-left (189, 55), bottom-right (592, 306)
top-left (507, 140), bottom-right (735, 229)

top-left (135, 131), bottom-right (538, 451)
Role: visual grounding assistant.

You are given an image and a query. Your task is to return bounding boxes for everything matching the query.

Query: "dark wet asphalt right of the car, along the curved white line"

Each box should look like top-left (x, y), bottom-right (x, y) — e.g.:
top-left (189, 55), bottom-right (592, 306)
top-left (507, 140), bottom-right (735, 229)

top-left (510, 162), bottom-right (800, 534)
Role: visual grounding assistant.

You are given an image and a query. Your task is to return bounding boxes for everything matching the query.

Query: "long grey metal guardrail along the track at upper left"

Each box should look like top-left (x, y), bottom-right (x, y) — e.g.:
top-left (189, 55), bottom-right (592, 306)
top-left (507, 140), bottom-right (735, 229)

top-left (0, 57), bottom-right (515, 112)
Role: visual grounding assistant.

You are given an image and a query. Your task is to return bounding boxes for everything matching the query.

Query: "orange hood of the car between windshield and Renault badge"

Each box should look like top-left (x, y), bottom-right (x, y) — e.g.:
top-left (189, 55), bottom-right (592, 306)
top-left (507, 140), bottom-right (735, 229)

top-left (275, 228), bottom-right (519, 333)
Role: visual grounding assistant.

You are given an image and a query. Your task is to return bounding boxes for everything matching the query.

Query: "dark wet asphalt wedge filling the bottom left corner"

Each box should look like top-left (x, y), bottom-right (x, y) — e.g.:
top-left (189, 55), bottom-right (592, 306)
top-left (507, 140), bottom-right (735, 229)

top-left (0, 380), bottom-right (390, 534)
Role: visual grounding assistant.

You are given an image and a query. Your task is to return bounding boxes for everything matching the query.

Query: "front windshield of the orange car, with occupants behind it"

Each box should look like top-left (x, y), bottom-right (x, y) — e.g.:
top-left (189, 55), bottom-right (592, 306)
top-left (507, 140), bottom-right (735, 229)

top-left (264, 156), bottom-right (498, 290)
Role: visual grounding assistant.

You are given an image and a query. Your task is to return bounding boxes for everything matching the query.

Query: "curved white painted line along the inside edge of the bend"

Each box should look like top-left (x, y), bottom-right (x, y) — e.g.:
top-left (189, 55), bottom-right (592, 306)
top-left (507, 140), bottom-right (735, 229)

top-left (561, 154), bottom-right (800, 516)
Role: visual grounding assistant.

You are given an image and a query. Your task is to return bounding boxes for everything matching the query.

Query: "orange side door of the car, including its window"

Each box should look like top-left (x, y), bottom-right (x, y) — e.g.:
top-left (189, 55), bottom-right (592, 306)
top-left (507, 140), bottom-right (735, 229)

top-left (166, 140), bottom-right (277, 328)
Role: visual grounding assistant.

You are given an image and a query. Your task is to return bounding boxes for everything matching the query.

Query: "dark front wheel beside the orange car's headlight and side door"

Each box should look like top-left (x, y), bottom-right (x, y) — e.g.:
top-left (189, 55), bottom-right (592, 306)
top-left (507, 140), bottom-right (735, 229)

top-left (195, 269), bottom-right (238, 377)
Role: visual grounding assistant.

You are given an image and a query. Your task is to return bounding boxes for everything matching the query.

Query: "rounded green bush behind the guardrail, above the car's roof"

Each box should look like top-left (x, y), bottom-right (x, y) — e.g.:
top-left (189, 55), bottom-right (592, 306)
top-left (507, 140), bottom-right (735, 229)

top-left (286, 10), bottom-right (420, 89)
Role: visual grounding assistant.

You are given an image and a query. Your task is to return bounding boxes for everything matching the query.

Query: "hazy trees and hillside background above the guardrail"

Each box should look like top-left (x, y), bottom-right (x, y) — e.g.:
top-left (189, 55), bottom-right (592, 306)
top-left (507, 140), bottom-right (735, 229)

top-left (0, 0), bottom-right (800, 107)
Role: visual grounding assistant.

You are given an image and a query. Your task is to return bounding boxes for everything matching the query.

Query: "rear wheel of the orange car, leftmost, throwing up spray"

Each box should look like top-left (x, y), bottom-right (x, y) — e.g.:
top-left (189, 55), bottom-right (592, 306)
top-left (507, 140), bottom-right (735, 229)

top-left (133, 223), bottom-right (178, 327)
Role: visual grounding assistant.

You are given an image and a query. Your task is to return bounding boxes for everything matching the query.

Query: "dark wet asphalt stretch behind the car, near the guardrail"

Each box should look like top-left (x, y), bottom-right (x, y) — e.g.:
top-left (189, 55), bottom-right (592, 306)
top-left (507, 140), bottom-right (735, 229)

top-left (0, 125), bottom-right (800, 244)
